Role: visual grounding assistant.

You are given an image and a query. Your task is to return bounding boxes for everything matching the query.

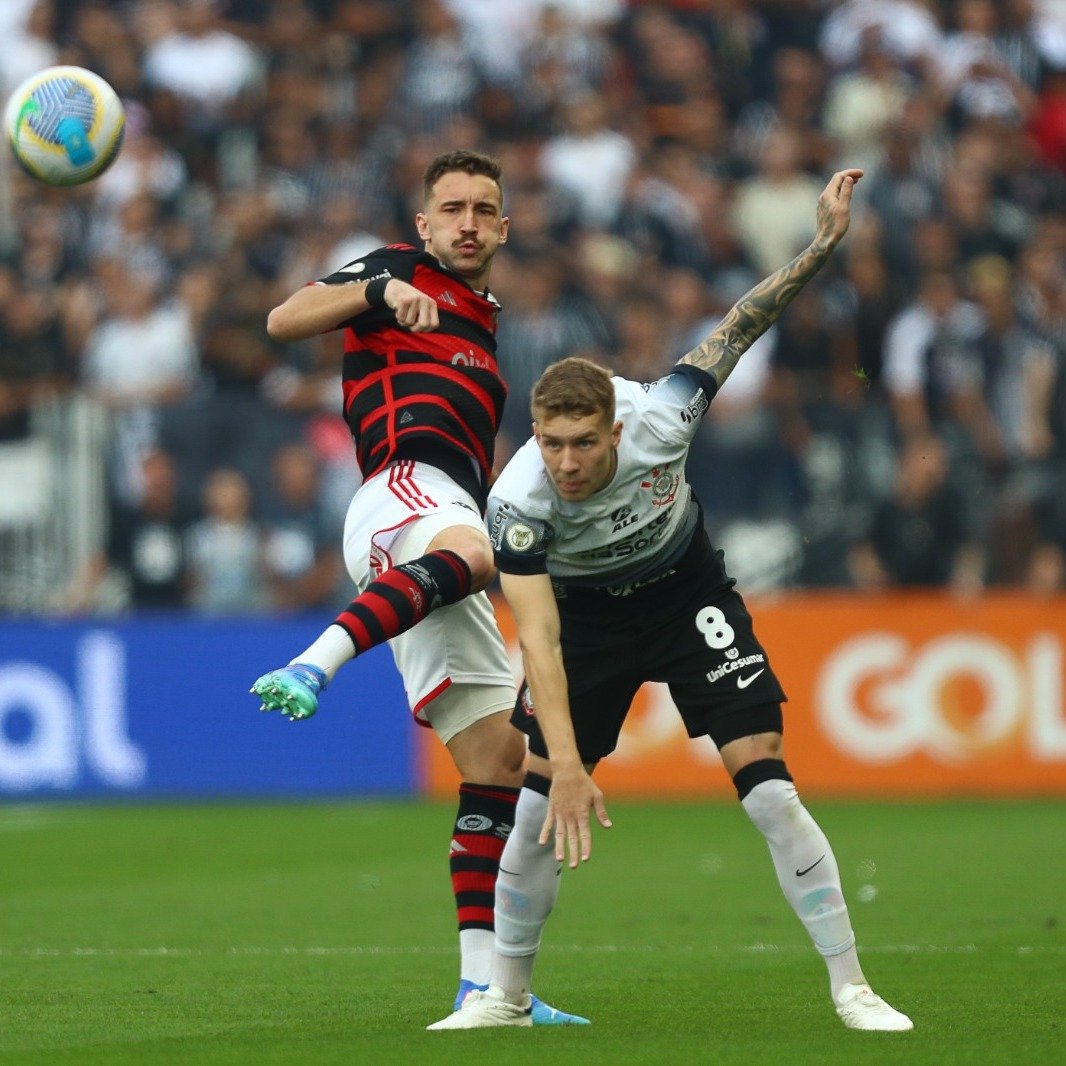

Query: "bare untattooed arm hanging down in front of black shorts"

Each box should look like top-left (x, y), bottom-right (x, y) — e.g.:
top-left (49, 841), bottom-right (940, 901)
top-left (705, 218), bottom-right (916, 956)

top-left (500, 574), bottom-right (611, 869)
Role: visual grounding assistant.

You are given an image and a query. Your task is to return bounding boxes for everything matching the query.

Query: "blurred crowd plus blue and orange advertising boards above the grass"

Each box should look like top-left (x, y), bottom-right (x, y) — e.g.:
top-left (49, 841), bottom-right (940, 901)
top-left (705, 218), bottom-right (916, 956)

top-left (0, 0), bottom-right (1066, 797)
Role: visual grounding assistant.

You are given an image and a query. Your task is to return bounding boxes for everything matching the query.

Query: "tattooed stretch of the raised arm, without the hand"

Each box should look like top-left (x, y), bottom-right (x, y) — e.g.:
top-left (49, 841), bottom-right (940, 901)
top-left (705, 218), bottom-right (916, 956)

top-left (678, 240), bottom-right (834, 388)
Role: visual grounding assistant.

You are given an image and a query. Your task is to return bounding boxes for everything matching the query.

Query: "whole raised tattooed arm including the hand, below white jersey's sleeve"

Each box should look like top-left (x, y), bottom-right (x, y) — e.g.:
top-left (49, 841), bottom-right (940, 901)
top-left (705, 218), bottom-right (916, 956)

top-left (678, 169), bottom-right (862, 388)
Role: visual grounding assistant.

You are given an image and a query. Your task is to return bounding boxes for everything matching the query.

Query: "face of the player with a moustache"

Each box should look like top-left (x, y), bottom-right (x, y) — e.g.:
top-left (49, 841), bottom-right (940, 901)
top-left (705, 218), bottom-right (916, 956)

top-left (415, 171), bottom-right (510, 288)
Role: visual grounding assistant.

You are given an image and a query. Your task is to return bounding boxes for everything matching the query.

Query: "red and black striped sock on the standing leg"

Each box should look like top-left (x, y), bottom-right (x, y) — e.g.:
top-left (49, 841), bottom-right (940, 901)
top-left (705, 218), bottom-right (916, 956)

top-left (449, 781), bottom-right (518, 930)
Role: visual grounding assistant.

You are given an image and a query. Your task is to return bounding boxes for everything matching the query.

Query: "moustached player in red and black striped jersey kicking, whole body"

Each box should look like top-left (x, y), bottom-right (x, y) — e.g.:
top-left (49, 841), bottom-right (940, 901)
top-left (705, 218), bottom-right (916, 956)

top-left (252, 150), bottom-right (585, 1024)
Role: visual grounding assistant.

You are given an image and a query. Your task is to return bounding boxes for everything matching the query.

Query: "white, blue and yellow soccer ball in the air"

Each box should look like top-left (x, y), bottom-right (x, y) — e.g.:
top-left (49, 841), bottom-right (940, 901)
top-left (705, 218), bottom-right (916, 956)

top-left (3, 66), bottom-right (126, 185)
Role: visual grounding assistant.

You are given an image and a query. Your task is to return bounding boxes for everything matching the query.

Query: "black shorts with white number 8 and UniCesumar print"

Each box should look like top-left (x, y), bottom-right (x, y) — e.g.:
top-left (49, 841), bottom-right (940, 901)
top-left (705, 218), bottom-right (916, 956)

top-left (511, 528), bottom-right (788, 762)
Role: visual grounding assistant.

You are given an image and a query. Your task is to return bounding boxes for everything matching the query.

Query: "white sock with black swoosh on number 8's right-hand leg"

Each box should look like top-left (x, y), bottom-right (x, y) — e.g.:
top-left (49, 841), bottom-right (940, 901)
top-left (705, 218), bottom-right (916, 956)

top-left (741, 780), bottom-right (866, 998)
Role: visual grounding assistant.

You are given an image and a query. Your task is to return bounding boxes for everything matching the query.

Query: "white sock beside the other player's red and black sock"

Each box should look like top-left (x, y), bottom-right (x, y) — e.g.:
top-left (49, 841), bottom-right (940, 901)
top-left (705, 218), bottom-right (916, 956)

top-left (491, 788), bottom-right (563, 1002)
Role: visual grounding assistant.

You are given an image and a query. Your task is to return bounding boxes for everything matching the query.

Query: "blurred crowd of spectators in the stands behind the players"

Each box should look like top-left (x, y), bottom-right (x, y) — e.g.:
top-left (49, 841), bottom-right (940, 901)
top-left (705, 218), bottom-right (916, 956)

top-left (0, 0), bottom-right (1066, 612)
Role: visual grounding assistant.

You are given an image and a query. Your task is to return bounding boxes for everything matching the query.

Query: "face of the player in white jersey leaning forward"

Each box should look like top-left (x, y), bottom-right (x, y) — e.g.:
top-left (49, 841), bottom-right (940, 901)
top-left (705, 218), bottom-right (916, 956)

top-left (533, 415), bottom-right (621, 501)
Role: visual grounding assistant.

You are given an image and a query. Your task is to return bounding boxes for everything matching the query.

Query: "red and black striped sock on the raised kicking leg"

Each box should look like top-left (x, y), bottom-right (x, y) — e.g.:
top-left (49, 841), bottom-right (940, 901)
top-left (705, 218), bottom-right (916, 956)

top-left (337, 549), bottom-right (470, 655)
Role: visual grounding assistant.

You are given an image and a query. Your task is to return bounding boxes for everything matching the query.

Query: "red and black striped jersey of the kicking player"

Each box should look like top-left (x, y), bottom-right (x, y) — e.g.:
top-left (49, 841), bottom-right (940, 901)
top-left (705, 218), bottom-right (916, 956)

top-left (321, 244), bottom-right (506, 510)
